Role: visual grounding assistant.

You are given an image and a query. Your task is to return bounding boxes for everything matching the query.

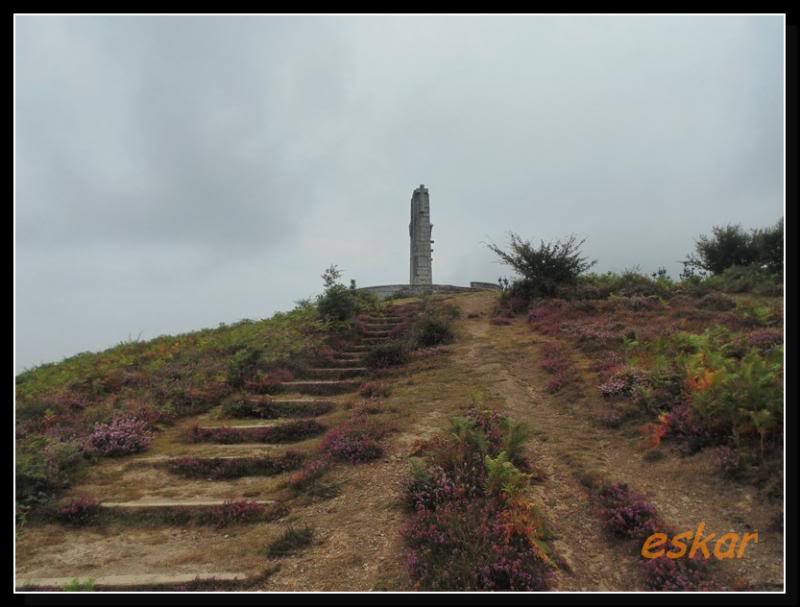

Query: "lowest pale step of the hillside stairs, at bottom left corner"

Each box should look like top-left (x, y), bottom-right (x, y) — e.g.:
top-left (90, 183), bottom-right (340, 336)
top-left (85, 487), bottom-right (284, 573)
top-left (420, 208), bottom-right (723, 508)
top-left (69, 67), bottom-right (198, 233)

top-left (16, 571), bottom-right (247, 592)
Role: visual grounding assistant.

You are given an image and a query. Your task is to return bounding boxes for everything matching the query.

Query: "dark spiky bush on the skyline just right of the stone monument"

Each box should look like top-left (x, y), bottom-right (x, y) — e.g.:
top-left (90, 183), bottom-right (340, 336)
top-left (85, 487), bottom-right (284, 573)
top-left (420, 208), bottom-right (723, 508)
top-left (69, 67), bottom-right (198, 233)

top-left (487, 232), bottom-right (596, 299)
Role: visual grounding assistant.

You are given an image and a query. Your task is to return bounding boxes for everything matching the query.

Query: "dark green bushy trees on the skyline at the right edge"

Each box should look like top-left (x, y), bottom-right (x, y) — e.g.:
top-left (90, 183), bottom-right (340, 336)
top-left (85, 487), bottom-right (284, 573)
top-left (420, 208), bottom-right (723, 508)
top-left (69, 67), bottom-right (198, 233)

top-left (683, 219), bottom-right (783, 274)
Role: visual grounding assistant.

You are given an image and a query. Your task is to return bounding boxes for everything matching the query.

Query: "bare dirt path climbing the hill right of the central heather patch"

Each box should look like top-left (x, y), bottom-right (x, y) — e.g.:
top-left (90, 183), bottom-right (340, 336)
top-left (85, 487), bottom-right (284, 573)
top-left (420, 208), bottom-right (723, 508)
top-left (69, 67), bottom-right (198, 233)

top-left (446, 297), bottom-right (783, 590)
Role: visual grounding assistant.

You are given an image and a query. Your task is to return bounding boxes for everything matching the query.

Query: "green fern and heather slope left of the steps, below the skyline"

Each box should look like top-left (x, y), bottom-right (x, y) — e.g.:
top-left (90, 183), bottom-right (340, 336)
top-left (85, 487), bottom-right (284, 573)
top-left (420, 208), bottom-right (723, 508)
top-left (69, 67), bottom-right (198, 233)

top-left (15, 305), bottom-right (324, 520)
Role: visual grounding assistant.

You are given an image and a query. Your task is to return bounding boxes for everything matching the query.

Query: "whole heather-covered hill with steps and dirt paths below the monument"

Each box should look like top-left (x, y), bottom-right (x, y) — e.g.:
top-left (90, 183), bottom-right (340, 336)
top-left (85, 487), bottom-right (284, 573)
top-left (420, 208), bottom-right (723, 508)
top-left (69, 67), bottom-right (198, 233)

top-left (17, 276), bottom-right (783, 590)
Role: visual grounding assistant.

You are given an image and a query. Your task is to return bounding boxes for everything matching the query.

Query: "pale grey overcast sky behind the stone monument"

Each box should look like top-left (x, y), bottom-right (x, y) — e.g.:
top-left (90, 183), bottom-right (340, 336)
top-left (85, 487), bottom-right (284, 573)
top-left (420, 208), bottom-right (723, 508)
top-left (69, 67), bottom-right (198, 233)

top-left (15, 16), bottom-right (784, 371)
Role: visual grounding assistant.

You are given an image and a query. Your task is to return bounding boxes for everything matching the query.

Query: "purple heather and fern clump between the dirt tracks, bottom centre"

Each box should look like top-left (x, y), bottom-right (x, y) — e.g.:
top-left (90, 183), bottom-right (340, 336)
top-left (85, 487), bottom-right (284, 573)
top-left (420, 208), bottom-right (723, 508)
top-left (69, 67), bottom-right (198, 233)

top-left (403, 410), bottom-right (554, 590)
